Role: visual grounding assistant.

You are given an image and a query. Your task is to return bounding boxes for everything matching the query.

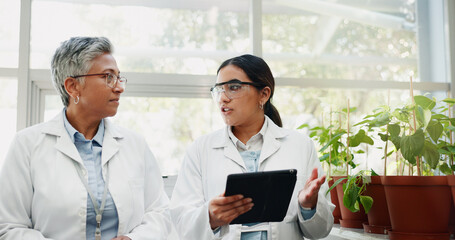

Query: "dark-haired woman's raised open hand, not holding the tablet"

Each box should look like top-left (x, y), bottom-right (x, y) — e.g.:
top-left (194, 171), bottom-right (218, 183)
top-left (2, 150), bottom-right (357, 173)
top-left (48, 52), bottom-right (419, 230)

top-left (299, 168), bottom-right (325, 208)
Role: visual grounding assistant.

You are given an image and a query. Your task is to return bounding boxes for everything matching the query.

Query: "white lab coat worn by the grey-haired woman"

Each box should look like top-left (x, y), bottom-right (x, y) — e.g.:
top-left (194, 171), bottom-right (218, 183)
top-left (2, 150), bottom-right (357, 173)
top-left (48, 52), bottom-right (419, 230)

top-left (0, 114), bottom-right (171, 240)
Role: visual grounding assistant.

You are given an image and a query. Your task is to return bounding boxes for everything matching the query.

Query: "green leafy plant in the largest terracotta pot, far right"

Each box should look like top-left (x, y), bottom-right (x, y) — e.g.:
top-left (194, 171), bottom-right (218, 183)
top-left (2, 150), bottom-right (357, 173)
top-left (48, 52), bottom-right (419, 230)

top-left (381, 93), bottom-right (451, 239)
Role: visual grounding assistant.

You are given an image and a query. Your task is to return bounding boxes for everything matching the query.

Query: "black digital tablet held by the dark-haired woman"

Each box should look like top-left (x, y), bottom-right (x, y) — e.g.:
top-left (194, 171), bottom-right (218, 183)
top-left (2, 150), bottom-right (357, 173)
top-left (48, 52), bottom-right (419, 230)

top-left (225, 169), bottom-right (297, 224)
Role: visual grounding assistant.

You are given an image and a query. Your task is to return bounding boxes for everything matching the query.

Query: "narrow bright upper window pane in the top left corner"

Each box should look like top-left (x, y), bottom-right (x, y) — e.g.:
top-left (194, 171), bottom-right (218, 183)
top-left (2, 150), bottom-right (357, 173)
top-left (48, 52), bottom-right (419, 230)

top-left (0, 0), bottom-right (21, 68)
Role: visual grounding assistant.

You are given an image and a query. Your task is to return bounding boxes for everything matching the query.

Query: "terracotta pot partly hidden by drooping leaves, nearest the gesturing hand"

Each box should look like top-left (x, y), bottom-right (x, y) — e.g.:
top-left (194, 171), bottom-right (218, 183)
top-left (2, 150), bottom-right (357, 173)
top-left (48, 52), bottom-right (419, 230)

top-left (333, 176), bottom-right (368, 228)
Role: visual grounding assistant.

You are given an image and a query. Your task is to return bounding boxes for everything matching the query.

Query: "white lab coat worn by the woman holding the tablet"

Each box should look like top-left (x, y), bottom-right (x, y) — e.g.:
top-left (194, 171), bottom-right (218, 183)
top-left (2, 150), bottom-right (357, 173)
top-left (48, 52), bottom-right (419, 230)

top-left (171, 117), bottom-right (335, 240)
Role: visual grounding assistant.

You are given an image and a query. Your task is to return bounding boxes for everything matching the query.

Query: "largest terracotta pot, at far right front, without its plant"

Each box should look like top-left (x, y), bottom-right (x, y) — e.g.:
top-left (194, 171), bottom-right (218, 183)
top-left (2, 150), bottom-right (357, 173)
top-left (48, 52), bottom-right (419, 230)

top-left (381, 176), bottom-right (453, 240)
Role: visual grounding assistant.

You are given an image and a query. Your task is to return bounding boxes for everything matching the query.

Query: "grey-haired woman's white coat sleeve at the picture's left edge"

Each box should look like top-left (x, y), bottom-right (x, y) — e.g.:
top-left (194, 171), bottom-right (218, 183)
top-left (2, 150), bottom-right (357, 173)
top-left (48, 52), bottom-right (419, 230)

top-left (0, 136), bottom-right (54, 240)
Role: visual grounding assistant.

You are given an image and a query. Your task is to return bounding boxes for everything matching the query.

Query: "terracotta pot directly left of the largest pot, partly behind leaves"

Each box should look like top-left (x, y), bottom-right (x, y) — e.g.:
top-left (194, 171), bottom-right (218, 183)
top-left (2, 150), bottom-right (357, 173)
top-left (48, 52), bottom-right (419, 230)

top-left (363, 176), bottom-right (392, 234)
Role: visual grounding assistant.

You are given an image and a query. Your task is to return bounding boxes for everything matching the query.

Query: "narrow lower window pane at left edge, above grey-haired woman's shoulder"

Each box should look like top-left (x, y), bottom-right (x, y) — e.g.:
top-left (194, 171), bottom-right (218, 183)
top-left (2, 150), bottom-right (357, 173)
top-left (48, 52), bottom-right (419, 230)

top-left (0, 77), bottom-right (17, 167)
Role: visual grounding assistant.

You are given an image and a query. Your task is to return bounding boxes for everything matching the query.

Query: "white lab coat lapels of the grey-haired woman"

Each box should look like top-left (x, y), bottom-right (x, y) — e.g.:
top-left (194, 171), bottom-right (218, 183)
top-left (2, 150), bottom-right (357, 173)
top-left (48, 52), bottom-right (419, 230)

top-left (42, 111), bottom-right (123, 165)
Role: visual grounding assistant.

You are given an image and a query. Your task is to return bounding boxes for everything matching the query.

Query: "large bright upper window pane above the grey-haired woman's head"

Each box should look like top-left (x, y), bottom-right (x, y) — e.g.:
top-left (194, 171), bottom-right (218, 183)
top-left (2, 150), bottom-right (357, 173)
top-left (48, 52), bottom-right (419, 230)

top-left (31, 1), bottom-right (249, 74)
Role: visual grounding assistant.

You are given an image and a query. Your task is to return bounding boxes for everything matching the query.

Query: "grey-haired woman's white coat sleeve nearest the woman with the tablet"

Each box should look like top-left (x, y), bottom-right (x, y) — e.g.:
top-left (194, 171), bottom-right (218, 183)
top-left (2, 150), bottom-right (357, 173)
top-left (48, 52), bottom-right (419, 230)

top-left (126, 143), bottom-right (171, 240)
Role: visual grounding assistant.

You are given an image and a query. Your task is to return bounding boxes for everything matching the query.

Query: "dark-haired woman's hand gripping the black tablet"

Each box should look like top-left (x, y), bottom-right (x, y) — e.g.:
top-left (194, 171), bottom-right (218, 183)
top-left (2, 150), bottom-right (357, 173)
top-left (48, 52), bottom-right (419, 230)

top-left (209, 193), bottom-right (254, 229)
